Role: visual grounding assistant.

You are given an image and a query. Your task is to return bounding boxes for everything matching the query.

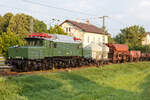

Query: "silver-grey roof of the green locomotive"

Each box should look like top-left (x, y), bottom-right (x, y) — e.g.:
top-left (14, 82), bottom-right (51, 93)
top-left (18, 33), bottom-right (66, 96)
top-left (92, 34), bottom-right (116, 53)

top-left (26, 34), bottom-right (81, 43)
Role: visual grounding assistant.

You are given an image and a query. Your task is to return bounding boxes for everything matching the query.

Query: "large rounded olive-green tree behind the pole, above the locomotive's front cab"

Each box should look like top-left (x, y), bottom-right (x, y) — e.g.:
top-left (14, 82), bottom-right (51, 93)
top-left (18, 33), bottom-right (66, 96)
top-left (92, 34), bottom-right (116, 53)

top-left (7, 14), bottom-right (47, 36)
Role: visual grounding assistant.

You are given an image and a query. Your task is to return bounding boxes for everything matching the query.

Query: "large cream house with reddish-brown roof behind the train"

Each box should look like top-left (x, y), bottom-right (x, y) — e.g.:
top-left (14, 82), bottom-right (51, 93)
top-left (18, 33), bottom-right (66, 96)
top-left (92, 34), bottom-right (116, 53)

top-left (60, 20), bottom-right (108, 47)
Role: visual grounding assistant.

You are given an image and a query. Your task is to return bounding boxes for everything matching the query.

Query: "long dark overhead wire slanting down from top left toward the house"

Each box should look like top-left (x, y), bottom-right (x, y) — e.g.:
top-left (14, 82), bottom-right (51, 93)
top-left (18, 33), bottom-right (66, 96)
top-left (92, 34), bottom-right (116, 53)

top-left (22, 0), bottom-right (95, 16)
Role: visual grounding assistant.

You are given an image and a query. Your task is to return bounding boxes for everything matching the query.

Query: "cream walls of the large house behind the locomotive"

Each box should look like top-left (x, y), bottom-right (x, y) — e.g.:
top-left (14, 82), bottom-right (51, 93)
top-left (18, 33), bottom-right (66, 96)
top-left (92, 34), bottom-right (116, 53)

top-left (61, 22), bottom-right (108, 47)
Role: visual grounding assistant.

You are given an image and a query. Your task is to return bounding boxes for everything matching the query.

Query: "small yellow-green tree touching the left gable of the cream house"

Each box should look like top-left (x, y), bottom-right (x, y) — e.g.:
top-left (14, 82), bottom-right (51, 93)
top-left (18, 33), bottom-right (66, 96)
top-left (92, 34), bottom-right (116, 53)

top-left (49, 25), bottom-right (67, 35)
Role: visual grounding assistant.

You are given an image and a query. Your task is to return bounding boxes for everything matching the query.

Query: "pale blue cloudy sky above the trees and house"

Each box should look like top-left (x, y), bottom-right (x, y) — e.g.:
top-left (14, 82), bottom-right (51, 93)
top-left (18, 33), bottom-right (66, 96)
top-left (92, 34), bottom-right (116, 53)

top-left (0, 0), bottom-right (150, 36)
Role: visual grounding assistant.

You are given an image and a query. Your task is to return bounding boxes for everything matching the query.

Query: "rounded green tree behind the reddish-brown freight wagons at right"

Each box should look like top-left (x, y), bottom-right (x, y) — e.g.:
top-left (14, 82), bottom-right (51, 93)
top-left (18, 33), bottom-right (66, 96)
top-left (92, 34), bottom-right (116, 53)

top-left (115, 25), bottom-right (145, 49)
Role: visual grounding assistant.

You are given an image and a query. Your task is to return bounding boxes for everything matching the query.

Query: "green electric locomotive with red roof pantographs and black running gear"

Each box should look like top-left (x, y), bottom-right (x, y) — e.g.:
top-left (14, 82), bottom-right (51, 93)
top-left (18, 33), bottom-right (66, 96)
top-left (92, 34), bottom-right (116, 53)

top-left (7, 33), bottom-right (88, 71)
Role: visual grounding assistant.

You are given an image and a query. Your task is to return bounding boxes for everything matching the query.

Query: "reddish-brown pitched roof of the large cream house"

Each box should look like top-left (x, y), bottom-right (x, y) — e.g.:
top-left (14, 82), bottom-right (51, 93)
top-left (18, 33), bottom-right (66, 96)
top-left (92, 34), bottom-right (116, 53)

top-left (60, 20), bottom-right (108, 35)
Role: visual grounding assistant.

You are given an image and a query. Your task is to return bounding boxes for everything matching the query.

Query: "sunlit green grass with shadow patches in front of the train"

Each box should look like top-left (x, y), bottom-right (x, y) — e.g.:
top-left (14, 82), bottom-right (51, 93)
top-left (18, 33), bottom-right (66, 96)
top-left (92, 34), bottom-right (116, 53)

top-left (0, 62), bottom-right (150, 100)
